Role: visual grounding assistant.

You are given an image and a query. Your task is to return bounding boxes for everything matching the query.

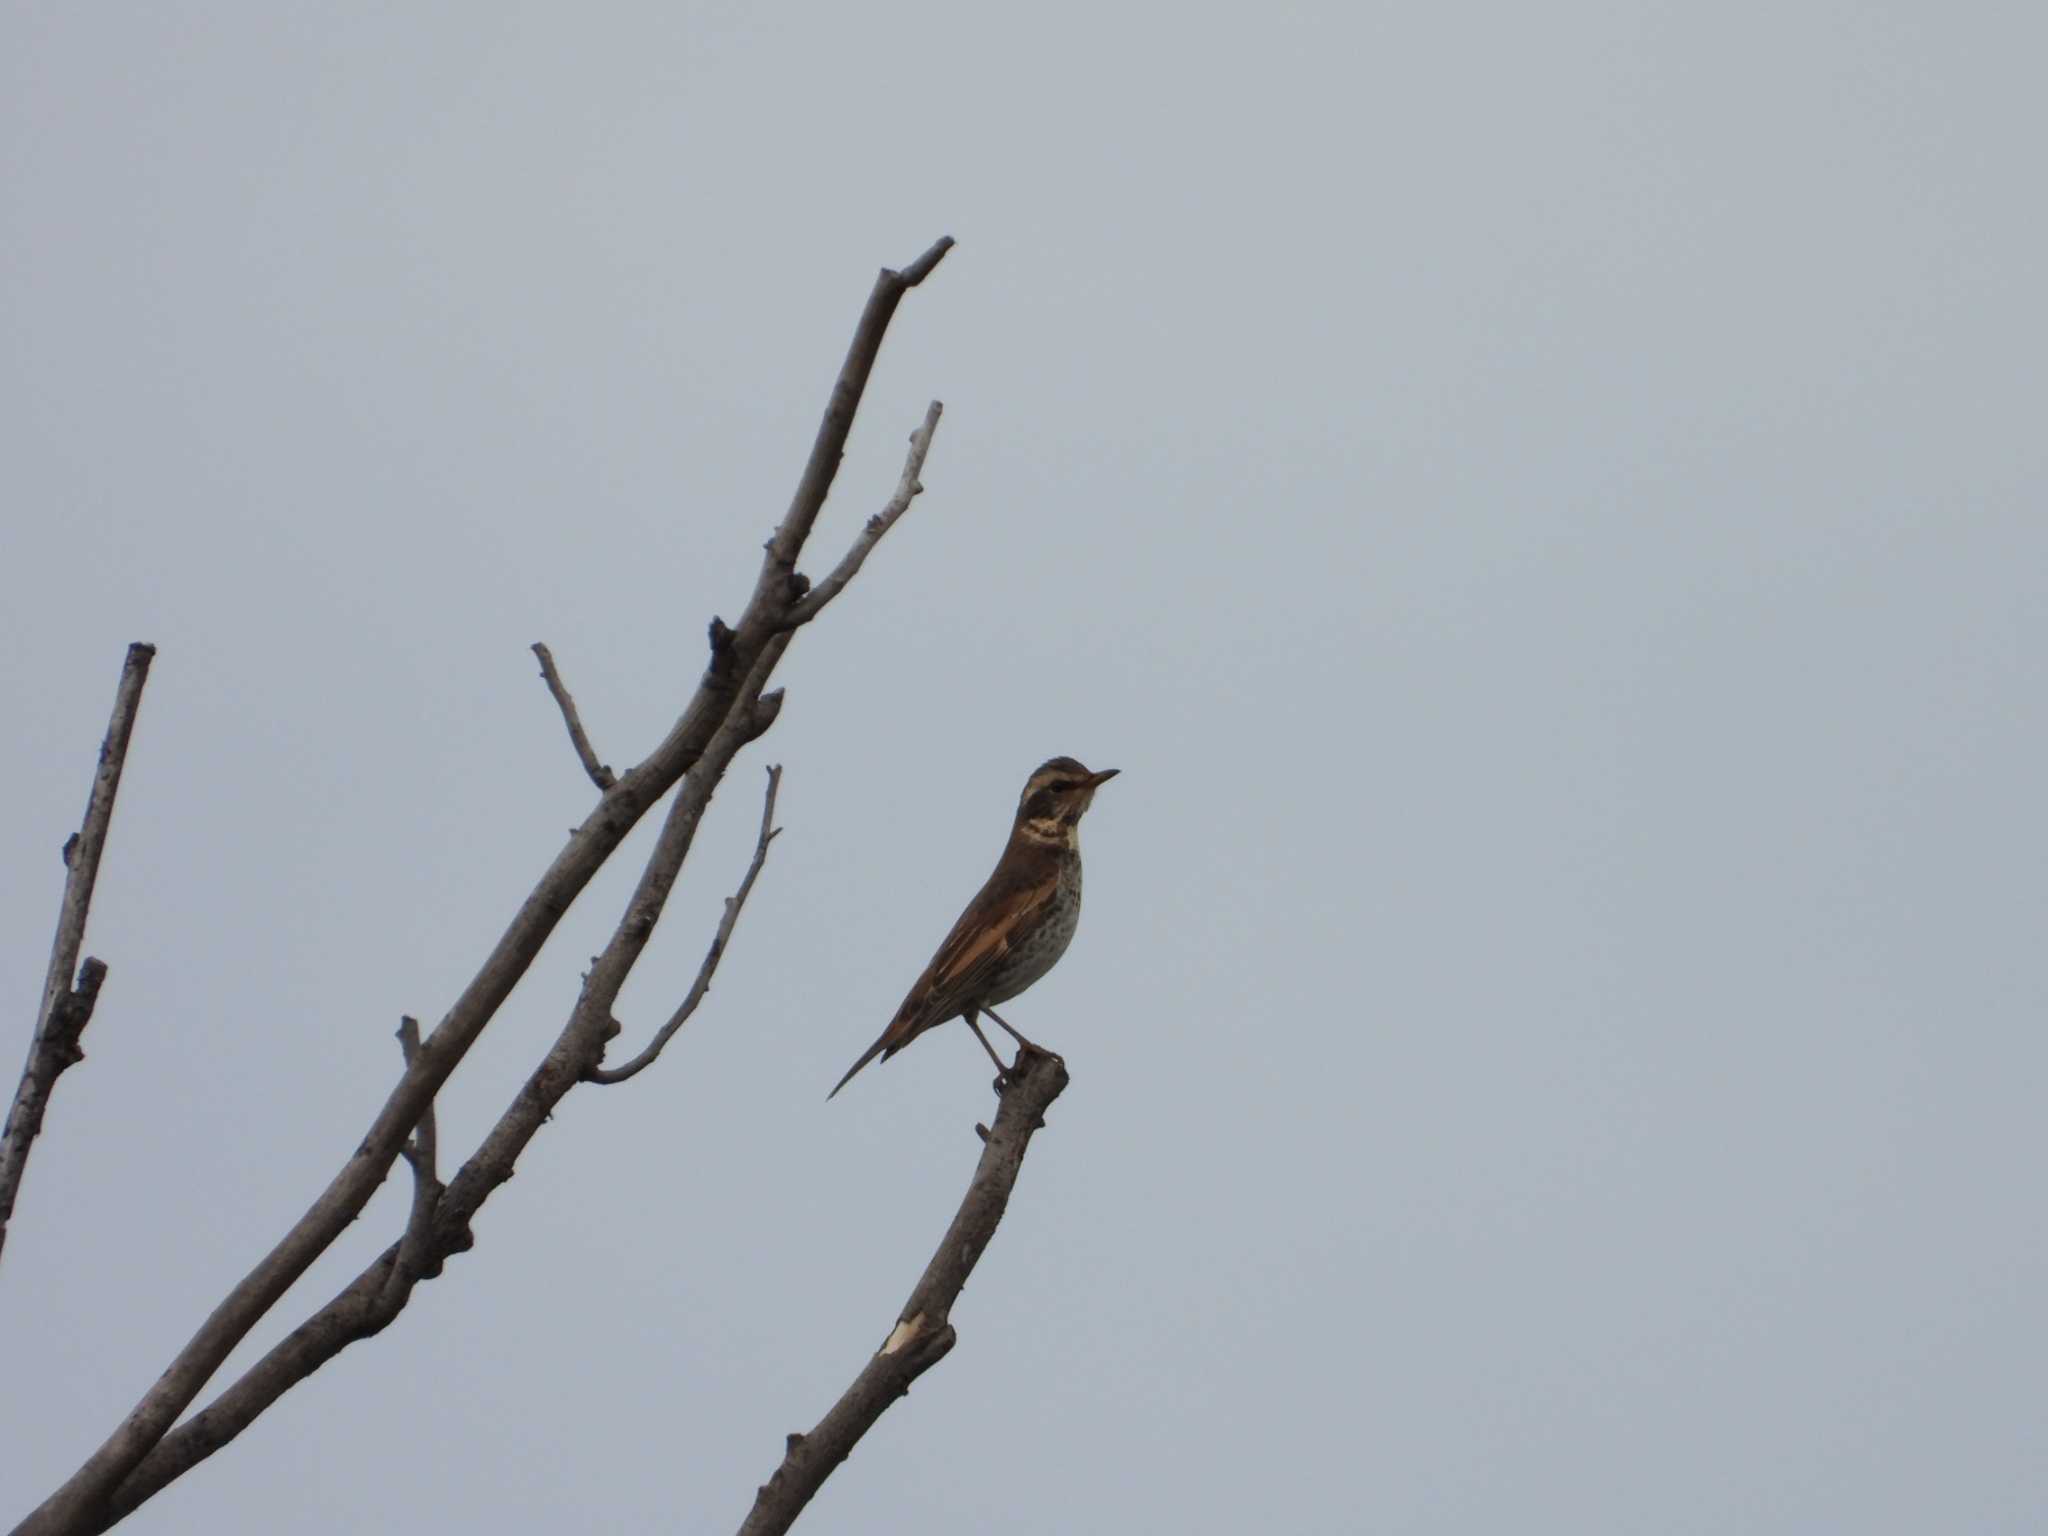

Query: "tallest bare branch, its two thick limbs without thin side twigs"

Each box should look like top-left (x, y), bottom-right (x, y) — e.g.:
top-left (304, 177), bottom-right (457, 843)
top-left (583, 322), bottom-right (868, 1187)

top-left (16, 238), bottom-right (952, 1536)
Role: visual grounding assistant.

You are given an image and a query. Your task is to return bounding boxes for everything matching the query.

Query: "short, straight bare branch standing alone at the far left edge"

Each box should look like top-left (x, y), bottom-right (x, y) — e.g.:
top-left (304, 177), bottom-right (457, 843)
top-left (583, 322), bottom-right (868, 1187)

top-left (0, 643), bottom-right (156, 1249)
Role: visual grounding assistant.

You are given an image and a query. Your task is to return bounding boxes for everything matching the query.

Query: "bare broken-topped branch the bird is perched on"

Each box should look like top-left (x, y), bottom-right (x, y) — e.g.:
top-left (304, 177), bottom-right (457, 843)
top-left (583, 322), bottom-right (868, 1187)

top-left (739, 1049), bottom-right (1067, 1536)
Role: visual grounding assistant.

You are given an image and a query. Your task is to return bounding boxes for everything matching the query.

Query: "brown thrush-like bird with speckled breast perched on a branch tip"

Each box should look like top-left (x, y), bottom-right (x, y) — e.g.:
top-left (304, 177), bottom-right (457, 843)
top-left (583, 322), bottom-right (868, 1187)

top-left (825, 758), bottom-right (1118, 1100)
